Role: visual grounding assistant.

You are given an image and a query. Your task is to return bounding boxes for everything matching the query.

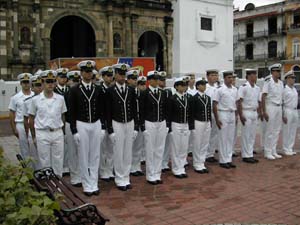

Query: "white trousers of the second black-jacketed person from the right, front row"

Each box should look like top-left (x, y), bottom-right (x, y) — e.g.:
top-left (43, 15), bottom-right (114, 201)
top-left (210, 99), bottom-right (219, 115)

top-left (171, 122), bottom-right (190, 175)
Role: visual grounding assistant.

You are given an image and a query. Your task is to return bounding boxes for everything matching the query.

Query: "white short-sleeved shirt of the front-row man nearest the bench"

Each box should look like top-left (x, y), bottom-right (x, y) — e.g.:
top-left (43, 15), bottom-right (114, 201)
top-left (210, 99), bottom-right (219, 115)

top-left (29, 92), bottom-right (67, 129)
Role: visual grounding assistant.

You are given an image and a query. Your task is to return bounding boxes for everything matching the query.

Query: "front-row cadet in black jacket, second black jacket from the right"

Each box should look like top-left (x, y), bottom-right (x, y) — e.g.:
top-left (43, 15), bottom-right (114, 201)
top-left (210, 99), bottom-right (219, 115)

top-left (167, 77), bottom-right (192, 179)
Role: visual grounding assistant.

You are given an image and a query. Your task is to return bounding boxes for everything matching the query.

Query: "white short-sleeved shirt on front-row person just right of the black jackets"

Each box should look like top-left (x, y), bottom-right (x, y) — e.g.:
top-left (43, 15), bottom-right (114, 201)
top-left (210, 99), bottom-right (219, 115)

top-left (213, 84), bottom-right (238, 111)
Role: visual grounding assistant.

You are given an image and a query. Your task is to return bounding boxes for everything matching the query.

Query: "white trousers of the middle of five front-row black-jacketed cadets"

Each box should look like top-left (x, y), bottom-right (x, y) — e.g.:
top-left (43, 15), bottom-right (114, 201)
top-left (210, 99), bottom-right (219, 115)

top-left (144, 121), bottom-right (168, 181)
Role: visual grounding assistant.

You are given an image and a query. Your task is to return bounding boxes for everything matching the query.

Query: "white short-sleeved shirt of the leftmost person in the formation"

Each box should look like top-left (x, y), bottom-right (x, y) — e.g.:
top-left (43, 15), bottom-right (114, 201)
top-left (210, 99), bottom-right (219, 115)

top-left (8, 91), bottom-right (34, 123)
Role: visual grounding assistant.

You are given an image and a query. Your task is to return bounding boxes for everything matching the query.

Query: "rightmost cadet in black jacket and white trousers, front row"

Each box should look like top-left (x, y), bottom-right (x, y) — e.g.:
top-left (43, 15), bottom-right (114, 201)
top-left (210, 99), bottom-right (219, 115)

top-left (191, 79), bottom-right (211, 174)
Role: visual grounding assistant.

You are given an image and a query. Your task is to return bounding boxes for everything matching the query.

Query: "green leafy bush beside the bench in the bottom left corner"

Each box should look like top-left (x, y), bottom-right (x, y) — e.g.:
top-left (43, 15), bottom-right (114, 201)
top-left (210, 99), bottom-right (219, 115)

top-left (0, 147), bottom-right (59, 225)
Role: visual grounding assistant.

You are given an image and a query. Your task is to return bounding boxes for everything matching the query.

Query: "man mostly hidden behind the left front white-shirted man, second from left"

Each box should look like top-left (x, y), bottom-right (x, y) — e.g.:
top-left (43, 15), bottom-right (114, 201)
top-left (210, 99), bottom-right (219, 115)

top-left (23, 74), bottom-right (43, 170)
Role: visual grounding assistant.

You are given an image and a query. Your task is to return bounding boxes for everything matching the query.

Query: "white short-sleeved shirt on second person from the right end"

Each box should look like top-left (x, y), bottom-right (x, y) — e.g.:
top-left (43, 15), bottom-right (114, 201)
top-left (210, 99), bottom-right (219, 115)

top-left (262, 77), bottom-right (283, 105)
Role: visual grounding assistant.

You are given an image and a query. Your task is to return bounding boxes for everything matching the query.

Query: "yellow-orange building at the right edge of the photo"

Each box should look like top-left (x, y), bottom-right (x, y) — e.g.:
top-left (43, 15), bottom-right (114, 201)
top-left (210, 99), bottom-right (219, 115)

top-left (284, 0), bottom-right (300, 83)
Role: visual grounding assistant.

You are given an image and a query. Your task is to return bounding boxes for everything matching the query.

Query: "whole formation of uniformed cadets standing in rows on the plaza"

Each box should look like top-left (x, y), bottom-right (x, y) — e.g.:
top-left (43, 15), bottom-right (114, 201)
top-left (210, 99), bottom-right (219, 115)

top-left (9, 60), bottom-right (298, 196)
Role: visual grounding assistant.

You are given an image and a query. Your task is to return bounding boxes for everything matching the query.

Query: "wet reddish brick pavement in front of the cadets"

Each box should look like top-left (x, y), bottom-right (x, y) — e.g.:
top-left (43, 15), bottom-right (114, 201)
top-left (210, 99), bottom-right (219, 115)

top-left (0, 118), bottom-right (300, 225)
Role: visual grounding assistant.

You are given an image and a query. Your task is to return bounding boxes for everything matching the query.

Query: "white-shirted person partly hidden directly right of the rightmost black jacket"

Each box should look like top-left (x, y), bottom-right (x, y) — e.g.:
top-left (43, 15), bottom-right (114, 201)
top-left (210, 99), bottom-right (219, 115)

top-left (205, 69), bottom-right (219, 163)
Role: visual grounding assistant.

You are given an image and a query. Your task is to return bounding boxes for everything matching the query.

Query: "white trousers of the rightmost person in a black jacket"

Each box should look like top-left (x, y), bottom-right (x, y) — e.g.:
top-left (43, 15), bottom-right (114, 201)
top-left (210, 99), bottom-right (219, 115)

top-left (191, 120), bottom-right (211, 170)
